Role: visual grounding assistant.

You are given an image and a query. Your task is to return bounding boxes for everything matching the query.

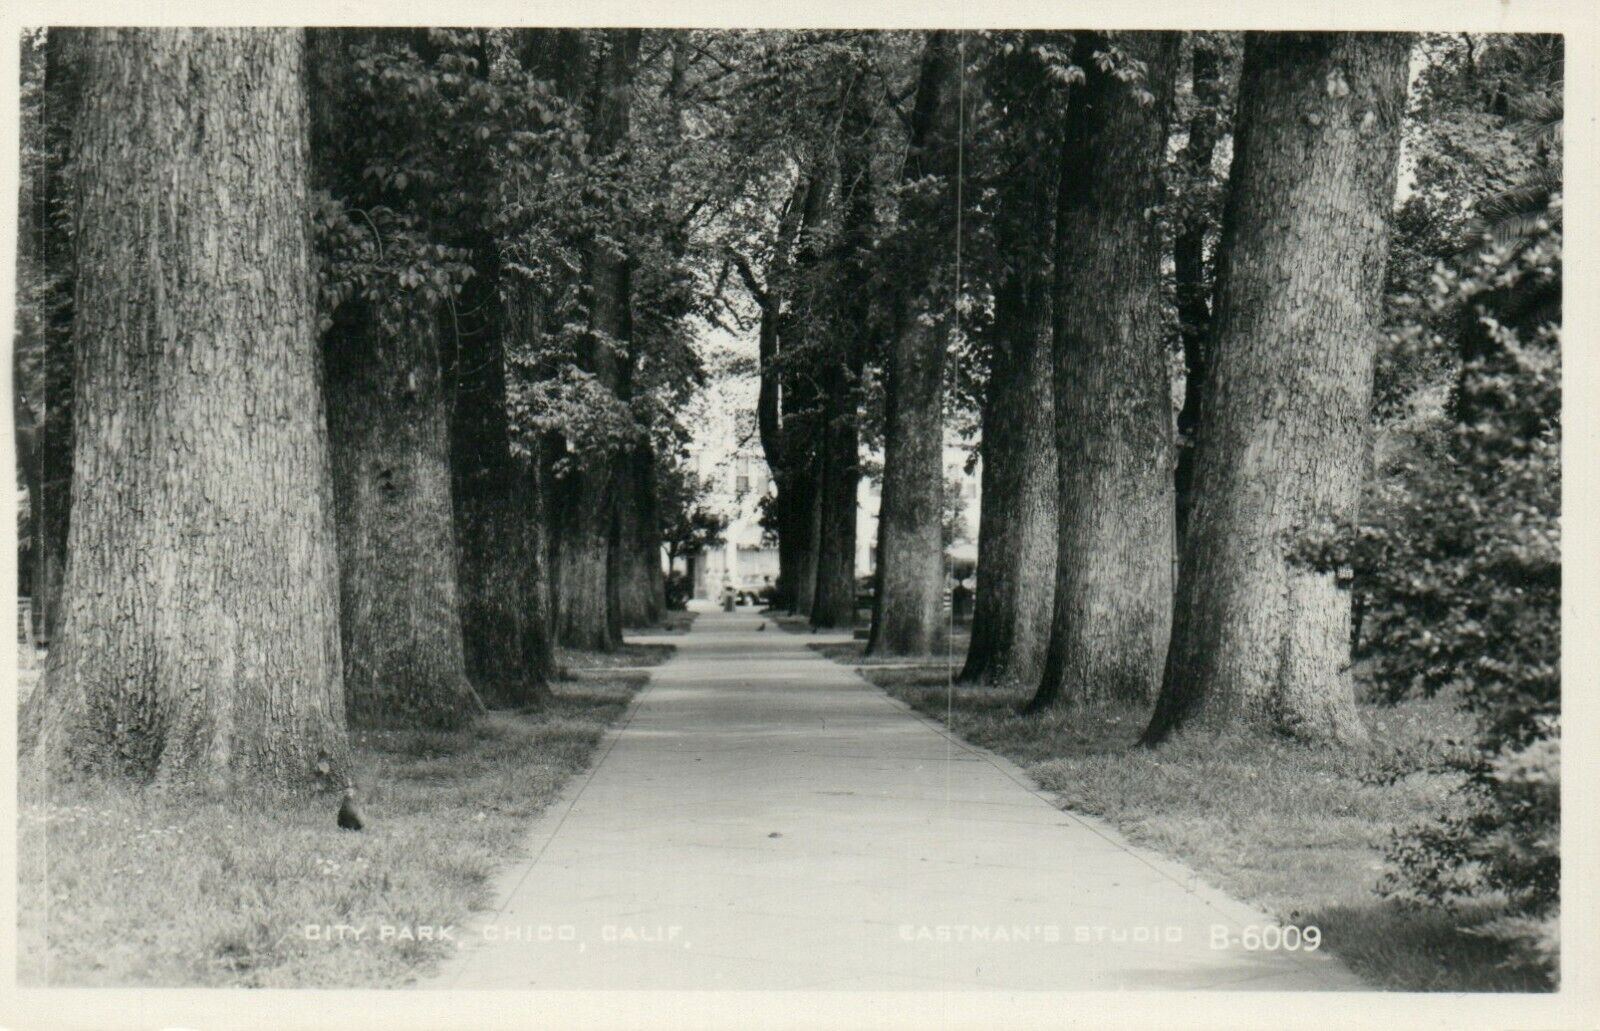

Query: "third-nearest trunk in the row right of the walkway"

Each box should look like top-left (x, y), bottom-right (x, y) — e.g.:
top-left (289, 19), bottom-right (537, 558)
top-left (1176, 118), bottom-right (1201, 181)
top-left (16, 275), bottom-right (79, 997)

top-left (960, 36), bottom-right (1061, 684)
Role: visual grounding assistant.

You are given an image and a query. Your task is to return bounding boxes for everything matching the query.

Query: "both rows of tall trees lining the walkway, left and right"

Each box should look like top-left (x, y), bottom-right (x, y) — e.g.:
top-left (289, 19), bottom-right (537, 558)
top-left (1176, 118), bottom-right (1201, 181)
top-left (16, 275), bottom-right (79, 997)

top-left (16, 30), bottom-right (1560, 819)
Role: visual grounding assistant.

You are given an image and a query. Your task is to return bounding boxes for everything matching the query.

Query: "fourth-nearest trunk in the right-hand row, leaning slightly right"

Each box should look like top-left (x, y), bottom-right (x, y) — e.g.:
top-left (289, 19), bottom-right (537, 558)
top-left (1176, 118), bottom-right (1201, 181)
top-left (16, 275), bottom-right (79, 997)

top-left (867, 32), bottom-right (960, 655)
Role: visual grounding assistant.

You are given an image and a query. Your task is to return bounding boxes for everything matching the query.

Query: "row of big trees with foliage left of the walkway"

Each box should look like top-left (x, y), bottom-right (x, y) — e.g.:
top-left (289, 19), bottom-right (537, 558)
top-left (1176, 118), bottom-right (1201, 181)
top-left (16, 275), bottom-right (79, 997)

top-left (14, 29), bottom-right (709, 788)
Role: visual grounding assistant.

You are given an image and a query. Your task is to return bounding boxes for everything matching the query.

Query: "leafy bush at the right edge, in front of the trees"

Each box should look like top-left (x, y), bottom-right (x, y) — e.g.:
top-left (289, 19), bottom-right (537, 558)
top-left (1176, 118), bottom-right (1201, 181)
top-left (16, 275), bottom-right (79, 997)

top-left (1299, 209), bottom-right (1562, 972)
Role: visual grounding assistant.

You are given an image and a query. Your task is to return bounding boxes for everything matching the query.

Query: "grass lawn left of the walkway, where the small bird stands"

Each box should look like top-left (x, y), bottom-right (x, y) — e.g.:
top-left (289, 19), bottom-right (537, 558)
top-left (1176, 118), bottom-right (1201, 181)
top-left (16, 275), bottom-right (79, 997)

top-left (18, 645), bottom-right (670, 988)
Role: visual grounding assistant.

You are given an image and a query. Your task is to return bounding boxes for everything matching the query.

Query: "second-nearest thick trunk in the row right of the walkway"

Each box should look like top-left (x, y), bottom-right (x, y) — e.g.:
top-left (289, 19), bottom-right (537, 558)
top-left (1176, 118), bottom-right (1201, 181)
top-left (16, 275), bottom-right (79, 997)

top-left (1030, 32), bottom-right (1178, 709)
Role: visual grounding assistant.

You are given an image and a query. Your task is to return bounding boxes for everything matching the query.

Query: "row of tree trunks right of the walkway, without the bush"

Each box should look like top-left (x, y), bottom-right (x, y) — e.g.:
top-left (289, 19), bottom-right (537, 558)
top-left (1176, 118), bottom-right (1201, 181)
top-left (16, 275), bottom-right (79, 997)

top-left (730, 32), bottom-right (1410, 740)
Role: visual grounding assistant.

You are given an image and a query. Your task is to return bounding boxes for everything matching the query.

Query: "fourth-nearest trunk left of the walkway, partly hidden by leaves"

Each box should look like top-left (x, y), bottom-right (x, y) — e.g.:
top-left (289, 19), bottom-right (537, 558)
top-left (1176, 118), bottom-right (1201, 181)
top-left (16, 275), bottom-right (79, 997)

top-left (555, 29), bottom-right (640, 652)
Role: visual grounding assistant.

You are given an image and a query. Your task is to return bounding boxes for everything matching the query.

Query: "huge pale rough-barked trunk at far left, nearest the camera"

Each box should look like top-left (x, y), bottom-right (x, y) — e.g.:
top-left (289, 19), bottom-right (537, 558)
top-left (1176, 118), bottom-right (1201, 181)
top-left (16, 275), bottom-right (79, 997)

top-left (24, 29), bottom-right (350, 791)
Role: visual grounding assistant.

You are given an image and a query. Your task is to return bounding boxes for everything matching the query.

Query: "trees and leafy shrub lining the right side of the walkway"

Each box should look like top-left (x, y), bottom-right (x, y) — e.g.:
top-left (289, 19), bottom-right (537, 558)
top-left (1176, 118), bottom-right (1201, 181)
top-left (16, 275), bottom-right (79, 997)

top-left (733, 32), bottom-right (1563, 941)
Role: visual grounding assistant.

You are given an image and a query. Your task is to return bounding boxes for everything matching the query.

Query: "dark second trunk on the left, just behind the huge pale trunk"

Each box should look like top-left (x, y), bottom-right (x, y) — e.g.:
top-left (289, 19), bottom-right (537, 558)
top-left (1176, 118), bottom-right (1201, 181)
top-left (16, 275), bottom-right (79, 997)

top-left (312, 29), bottom-right (482, 727)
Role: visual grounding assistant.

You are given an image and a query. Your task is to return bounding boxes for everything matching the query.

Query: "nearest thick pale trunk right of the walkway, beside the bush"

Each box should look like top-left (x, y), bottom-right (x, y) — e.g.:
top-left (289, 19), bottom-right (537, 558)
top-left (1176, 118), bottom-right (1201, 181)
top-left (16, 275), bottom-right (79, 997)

top-left (1146, 32), bottom-right (1406, 743)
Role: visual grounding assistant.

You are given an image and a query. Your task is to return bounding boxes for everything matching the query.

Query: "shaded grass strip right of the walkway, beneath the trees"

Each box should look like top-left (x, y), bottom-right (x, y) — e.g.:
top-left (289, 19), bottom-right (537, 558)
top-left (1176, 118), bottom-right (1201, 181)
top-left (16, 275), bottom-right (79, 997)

top-left (814, 642), bottom-right (1550, 991)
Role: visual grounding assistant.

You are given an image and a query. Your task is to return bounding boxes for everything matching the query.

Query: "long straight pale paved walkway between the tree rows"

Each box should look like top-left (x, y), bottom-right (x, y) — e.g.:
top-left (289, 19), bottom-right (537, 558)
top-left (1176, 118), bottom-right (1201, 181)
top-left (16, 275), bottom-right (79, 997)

top-left (424, 612), bottom-right (1360, 991)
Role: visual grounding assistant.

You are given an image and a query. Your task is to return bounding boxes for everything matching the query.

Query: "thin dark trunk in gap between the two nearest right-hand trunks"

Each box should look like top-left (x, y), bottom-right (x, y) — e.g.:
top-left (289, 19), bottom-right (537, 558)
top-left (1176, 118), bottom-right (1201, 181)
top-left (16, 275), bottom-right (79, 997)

top-left (1173, 37), bottom-right (1222, 541)
